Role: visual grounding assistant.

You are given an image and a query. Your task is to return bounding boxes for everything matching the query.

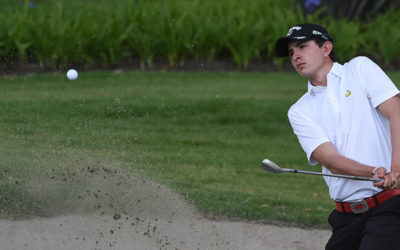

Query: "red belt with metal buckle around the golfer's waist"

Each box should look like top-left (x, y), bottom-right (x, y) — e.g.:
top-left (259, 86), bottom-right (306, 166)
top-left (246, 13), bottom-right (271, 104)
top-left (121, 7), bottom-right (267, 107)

top-left (336, 189), bottom-right (400, 214)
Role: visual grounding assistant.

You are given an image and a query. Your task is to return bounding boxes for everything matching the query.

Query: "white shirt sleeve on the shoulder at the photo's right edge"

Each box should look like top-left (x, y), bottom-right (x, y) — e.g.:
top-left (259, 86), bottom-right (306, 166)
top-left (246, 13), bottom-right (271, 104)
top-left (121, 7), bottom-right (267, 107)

top-left (356, 57), bottom-right (399, 108)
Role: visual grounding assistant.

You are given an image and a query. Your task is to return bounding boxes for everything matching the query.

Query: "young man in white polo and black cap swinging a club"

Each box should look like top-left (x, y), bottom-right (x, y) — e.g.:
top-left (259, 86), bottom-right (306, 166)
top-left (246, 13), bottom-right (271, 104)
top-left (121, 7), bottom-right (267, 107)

top-left (275, 23), bottom-right (400, 250)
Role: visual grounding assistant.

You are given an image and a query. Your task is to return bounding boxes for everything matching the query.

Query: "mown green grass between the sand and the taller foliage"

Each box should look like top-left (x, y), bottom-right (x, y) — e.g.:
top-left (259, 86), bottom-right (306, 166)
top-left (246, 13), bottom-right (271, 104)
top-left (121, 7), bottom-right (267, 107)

top-left (0, 72), bottom-right (400, 226)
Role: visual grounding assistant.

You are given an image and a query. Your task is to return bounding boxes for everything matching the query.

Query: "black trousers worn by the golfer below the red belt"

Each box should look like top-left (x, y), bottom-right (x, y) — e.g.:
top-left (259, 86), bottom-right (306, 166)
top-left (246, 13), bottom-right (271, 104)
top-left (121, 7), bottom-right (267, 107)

top-left (325, 195), bottom-right (400, 250)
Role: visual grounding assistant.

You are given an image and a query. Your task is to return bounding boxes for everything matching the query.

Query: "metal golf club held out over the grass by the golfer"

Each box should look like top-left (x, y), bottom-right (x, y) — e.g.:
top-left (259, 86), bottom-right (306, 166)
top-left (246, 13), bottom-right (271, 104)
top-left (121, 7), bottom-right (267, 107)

top-left (261, 159), bottom-right (383, 182)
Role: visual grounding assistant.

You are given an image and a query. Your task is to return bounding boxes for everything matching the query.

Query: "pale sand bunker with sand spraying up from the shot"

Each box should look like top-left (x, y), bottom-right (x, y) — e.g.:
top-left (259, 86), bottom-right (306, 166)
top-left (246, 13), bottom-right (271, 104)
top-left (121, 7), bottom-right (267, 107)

top-left (0, 167), bottom-right (330, 250)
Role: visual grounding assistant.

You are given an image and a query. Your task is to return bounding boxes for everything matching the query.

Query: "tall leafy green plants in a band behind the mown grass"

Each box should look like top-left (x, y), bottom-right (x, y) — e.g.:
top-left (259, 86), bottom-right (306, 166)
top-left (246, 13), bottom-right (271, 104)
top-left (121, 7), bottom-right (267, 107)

top-left (0, 0), bottom-right (400, 69)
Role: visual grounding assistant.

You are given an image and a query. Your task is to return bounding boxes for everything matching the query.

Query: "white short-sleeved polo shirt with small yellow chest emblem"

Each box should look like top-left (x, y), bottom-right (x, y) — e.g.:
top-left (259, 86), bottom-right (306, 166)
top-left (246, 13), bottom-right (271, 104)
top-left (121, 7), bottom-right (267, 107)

top-left (288, 57), bottom-right (399, 202)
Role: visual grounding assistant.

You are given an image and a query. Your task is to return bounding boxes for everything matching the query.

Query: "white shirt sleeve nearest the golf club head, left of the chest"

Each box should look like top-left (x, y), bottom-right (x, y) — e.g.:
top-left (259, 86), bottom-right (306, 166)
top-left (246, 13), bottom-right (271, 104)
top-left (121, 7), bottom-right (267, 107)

top-left (288, 104), bottom-right (330, 166)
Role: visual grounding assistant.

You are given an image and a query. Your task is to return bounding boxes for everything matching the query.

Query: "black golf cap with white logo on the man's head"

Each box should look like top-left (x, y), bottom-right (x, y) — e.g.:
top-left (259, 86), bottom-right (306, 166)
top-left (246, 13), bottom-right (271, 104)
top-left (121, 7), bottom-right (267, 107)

top-left (275, 23), bottom-right (333, 57)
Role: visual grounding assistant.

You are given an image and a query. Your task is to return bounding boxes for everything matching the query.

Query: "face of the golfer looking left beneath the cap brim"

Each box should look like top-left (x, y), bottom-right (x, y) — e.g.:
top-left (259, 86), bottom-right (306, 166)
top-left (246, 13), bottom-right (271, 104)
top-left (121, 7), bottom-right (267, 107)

top-left (288, 40), bottom-right (327, 79)
